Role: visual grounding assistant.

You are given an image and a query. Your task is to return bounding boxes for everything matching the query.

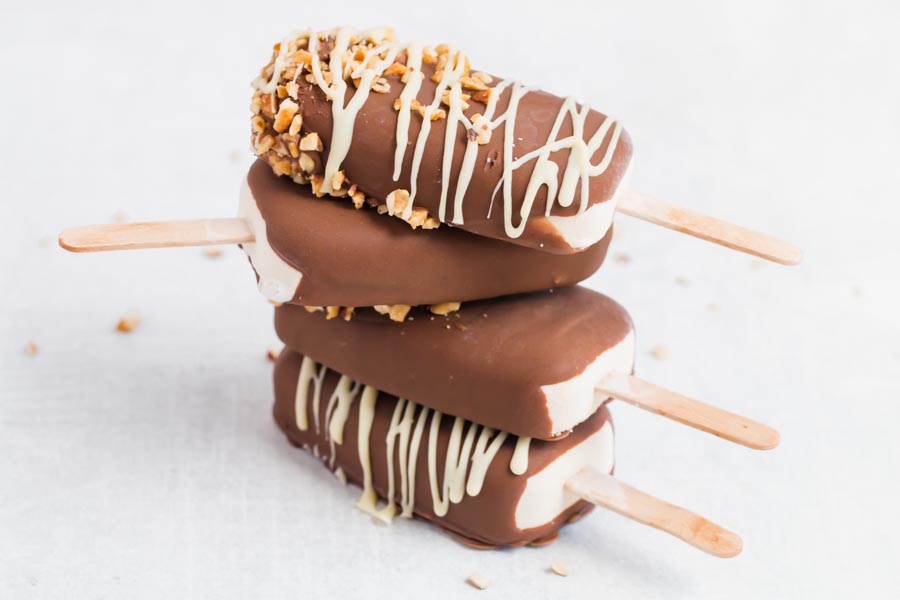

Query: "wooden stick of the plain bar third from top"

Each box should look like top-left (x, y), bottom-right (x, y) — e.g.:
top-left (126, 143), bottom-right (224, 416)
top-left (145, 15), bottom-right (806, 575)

top-left (597, 372), bottom-right (780, 450)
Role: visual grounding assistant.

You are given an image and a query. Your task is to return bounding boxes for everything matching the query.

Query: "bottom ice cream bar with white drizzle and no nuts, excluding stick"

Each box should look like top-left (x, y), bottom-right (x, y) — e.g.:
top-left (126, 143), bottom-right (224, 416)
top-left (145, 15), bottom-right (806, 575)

top-left (274, 350), bottom-right (613, 547)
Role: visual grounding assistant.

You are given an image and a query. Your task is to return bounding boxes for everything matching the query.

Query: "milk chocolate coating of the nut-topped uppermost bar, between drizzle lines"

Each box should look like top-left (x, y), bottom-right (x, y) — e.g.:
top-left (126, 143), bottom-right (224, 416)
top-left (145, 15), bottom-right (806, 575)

top-left (260, 41), bottom-right (632, 254)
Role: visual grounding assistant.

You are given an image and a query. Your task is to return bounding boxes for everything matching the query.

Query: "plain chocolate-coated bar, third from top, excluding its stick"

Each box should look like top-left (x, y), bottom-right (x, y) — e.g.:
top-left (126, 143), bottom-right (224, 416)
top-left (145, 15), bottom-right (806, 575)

top-left (275, 286), bottom-right (634, 439)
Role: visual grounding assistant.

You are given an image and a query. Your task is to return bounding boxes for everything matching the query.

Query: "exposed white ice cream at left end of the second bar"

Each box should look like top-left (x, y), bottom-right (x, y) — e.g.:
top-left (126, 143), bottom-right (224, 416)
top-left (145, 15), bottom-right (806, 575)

top-left (238, 179), bottom-right (303, 302)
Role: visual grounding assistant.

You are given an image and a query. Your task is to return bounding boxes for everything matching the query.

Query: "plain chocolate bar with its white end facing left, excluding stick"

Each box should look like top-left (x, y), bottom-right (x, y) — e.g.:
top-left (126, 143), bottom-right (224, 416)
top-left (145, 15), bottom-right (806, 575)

top-left (240, 161), bottom-right (612, 306)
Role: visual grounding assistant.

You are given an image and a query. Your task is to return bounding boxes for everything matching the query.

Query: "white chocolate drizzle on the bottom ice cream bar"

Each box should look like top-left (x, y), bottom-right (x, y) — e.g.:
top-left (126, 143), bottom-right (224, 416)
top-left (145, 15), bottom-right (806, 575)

top-left (294, 357), bottom-right (531, 523)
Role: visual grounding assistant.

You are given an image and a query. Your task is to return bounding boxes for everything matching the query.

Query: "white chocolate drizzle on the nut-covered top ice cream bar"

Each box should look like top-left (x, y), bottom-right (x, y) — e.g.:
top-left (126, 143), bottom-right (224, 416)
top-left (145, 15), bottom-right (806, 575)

top-left (254, 28), bottom-right (622, 239)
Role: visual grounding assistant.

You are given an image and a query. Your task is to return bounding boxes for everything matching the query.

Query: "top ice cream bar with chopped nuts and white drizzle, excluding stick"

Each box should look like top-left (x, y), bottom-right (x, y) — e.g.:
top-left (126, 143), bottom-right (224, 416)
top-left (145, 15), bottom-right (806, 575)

top-left (251, 28), bottom-right (632, 253)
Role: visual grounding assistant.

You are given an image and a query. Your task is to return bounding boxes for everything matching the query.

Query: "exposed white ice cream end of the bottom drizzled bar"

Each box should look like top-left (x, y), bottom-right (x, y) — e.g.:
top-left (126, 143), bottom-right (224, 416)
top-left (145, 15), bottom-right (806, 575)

top-left (516, 421), bottom-right (615, 529)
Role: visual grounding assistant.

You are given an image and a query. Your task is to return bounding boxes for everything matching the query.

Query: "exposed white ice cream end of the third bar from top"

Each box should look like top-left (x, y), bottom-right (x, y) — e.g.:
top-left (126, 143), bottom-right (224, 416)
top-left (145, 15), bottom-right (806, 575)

top-left (541, 330), bottom-right (634, 435)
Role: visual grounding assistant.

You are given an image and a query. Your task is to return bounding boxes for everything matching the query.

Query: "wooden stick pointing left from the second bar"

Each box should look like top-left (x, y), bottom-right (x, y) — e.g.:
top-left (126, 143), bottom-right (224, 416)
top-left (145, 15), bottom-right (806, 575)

top-left (59, 218), bottom-right (254, 252)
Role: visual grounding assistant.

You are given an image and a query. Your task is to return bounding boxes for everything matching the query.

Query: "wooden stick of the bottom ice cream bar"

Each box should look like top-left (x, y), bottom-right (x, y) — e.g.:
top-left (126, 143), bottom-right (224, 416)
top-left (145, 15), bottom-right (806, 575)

top-left (565, 467), bottom-right (744, 558)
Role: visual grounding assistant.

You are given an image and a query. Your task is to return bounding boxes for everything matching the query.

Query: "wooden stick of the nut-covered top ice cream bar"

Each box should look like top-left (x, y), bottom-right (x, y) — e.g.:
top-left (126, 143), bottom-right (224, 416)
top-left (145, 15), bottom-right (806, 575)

top-left (616, 189), bottom-right (803, 265)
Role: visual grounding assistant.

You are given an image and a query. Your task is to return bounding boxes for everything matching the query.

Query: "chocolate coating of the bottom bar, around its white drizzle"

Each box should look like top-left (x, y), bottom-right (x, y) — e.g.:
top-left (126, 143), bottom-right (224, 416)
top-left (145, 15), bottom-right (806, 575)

top-left (273, 351), bottom-right (610, 548)
